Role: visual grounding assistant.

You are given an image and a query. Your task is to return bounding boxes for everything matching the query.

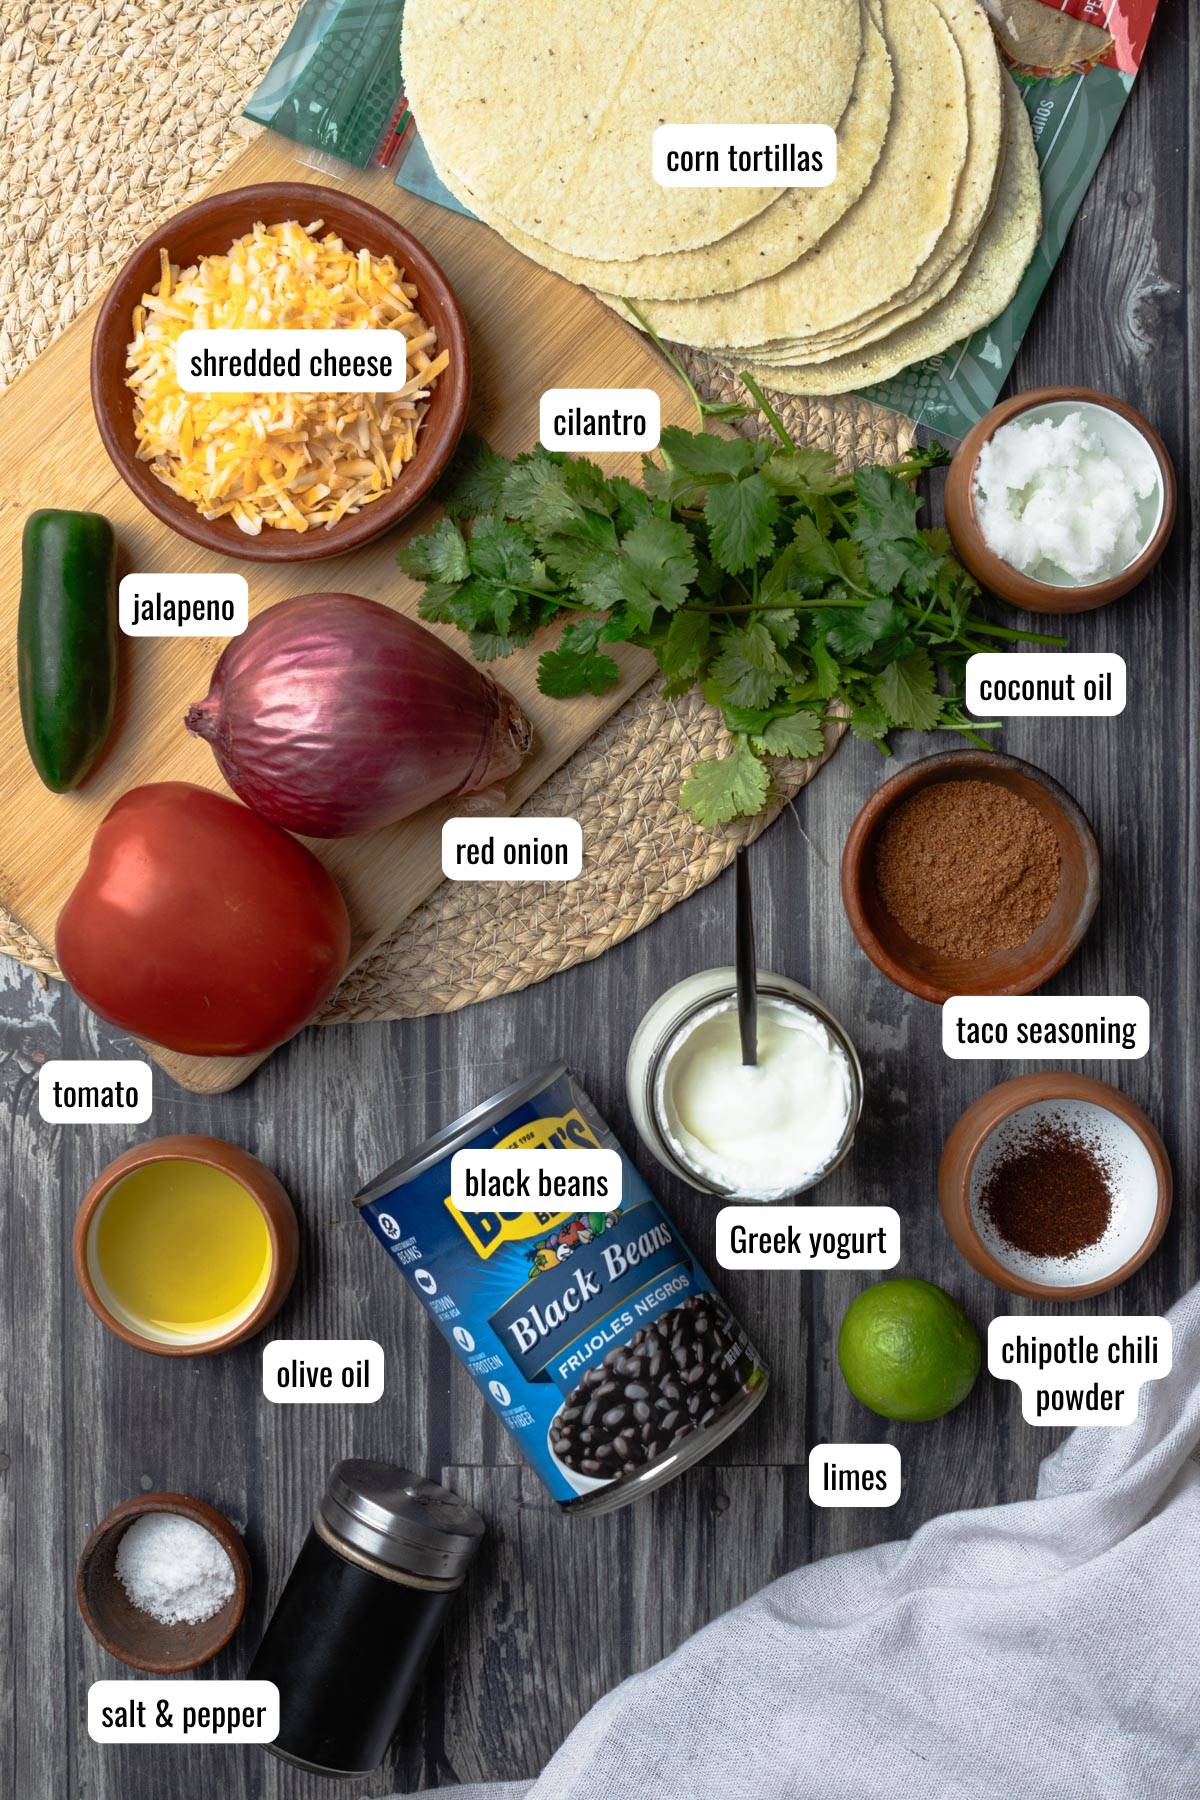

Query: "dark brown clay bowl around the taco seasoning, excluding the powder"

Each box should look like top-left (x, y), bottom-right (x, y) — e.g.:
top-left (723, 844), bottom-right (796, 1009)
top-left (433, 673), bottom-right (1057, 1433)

top-left (842, 751), bottom-right (1099, 1004)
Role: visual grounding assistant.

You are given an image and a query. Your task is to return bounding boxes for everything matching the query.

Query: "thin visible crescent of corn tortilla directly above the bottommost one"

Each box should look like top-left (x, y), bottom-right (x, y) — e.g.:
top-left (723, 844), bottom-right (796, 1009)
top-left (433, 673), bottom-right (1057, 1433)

top-left (759, 0), bottom-right (1004, 364)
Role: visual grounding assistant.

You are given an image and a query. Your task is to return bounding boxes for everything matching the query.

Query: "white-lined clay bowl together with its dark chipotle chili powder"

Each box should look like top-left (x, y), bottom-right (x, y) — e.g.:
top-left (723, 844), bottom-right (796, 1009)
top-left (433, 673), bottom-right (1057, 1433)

top-left (937, 1069), bottom-right (1173, 1300)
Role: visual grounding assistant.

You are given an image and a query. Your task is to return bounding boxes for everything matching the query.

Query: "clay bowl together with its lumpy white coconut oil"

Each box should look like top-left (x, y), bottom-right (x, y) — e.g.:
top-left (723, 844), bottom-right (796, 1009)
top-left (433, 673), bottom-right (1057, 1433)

top-left (945, 387), bottom-right (1177, 612)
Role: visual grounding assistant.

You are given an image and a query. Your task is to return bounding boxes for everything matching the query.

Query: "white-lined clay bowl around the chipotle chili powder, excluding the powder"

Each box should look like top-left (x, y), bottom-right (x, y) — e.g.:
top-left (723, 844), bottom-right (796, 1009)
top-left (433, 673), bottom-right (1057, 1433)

top-left (937, 1069), bottom-right (1173, 1300)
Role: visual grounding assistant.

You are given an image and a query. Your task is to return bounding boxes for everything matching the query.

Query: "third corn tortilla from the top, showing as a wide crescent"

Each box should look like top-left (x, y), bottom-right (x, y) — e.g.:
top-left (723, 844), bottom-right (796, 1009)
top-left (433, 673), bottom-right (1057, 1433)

top-left (601, 0), bottom-right (968, 349)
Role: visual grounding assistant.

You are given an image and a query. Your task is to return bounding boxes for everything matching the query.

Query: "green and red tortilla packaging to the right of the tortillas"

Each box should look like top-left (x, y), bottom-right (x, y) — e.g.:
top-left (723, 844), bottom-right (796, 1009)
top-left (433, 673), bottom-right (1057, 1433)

top-left (860, 0), bottom-right (1157, 437)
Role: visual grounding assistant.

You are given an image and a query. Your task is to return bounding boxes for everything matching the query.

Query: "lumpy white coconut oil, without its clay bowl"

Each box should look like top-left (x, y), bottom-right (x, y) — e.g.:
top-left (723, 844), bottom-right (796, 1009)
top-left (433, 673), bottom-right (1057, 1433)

top-left (973, 400), bottom-right (1162, 587)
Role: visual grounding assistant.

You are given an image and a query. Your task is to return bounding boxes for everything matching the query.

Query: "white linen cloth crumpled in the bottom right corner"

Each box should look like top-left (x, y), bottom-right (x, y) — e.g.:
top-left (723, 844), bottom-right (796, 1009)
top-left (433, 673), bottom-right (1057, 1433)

top-left (390, 1287), bottom-right (1200, 1800)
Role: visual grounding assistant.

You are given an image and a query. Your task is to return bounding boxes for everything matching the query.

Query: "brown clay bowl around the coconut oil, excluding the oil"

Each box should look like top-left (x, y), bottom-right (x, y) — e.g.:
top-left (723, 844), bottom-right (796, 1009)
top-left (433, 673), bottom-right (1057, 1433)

top-left (943, 387), bottom-right (1177, 612)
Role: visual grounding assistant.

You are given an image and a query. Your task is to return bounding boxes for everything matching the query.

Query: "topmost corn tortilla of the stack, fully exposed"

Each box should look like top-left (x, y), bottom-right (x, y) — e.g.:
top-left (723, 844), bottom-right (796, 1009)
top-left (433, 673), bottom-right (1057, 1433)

top-left (401, 0), bottom-right (864, 261)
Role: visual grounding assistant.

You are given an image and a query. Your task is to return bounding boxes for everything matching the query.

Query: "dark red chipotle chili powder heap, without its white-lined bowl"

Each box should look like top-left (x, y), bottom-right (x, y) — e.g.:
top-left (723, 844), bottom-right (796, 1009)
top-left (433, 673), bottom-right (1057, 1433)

top-left (979, 1118), bottom-right (1112, 1258)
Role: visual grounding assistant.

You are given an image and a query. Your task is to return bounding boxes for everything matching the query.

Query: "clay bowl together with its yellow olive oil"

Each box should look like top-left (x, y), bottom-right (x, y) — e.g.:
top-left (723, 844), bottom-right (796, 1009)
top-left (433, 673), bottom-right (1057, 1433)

top-left (74, 1136), bottom-right (299, 1355)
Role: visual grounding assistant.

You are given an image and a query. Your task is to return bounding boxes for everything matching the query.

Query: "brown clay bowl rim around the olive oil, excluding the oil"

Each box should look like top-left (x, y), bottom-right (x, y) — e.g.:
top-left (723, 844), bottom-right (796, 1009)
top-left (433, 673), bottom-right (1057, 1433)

top-left (72, 1136), bottom-right (300, 1355)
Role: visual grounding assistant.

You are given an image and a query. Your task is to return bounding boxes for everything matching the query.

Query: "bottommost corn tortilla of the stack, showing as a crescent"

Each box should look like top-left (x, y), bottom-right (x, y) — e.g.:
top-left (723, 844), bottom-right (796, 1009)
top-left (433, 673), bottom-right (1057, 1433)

top-left (750, 74), bottom-right (1042, 394)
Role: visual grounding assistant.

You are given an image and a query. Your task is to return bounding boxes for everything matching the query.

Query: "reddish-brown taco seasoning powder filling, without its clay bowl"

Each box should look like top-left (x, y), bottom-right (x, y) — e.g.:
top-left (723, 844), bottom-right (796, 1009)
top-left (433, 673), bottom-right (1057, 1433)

top-left (874, 781), bottom-right (1061, 961)
